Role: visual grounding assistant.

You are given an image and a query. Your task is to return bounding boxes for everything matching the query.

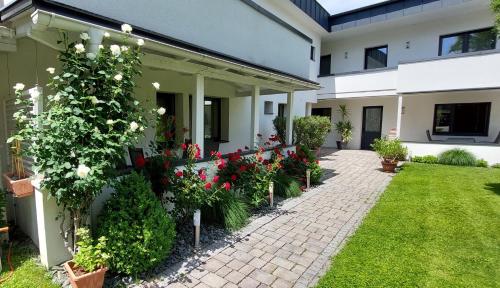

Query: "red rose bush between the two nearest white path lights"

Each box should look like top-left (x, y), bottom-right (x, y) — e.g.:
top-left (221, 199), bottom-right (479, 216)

top-left (217, 147), bottom-right (283, 207)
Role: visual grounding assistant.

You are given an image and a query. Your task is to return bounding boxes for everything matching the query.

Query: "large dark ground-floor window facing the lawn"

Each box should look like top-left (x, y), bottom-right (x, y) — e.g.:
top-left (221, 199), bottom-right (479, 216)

top-left (432, 102), bottom-right (491, 136)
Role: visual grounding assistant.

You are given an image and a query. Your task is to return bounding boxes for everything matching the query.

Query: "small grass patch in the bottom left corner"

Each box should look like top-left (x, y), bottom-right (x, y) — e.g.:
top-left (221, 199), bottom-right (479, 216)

top-left (0, 239), bottom-right (59, 288)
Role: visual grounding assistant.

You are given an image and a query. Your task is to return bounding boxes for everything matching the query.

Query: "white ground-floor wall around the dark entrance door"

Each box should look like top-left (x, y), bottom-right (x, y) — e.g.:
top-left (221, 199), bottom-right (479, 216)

top-left (313, 97), bottom-right (397, 149)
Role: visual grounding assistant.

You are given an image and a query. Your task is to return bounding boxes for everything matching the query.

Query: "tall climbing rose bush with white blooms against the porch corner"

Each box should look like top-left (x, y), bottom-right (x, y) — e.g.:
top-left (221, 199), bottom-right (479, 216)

top-left (8, 24), bottom-right (157, 252)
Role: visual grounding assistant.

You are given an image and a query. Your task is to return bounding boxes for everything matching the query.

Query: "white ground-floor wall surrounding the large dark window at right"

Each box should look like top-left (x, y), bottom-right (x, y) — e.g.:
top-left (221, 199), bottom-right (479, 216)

top-left (401, 90), bottom-right (500, 142)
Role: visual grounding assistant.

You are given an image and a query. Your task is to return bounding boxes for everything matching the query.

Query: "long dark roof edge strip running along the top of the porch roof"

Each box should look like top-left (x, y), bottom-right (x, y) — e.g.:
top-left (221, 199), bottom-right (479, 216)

top-left (0, 0), bottom-right (319, 85)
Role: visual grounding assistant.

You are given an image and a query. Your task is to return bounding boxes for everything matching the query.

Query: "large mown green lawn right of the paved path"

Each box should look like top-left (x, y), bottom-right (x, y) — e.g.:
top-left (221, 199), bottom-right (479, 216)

top-left (318, 164), bottom-right (500, 287)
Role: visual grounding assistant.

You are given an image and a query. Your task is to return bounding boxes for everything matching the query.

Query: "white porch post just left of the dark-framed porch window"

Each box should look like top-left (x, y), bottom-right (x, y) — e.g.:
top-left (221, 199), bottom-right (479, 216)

top-left (191, 74), bottom-right (205, 155)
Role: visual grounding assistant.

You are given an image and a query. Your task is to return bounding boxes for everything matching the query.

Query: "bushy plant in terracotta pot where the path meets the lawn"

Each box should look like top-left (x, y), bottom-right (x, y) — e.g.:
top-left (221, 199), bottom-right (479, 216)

top-left (371, 138), bottom-right (408, 172)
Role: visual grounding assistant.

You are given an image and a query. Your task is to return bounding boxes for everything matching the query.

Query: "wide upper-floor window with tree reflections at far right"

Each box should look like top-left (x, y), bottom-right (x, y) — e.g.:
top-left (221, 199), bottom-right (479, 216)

top-left (439, 28), bottom-right (496, 56)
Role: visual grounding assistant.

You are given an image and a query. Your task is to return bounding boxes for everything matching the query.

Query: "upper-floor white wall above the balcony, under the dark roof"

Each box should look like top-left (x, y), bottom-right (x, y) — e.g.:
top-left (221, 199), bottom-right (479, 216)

top-left (321, 8), bottom-right (493, 73)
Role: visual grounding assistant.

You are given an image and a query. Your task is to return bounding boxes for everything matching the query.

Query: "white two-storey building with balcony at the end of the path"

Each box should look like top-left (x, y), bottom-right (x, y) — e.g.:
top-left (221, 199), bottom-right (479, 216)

top-left (313, 0), bottom-right (500, 163)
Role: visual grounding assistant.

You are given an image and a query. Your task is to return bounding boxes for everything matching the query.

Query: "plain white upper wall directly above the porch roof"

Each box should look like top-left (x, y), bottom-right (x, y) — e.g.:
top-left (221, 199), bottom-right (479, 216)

top-left (58, 0), bottom-right (310, 77)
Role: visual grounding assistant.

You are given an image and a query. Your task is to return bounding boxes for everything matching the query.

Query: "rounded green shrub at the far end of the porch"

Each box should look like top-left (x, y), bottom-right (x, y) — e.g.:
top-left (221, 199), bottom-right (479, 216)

top-left (293, 116), bottom-right (332, 150)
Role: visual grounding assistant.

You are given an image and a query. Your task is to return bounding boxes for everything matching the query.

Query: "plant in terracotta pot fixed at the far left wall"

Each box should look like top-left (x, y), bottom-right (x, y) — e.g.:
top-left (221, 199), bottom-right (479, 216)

top-left (3, 139), bottom-right (33, 197)
